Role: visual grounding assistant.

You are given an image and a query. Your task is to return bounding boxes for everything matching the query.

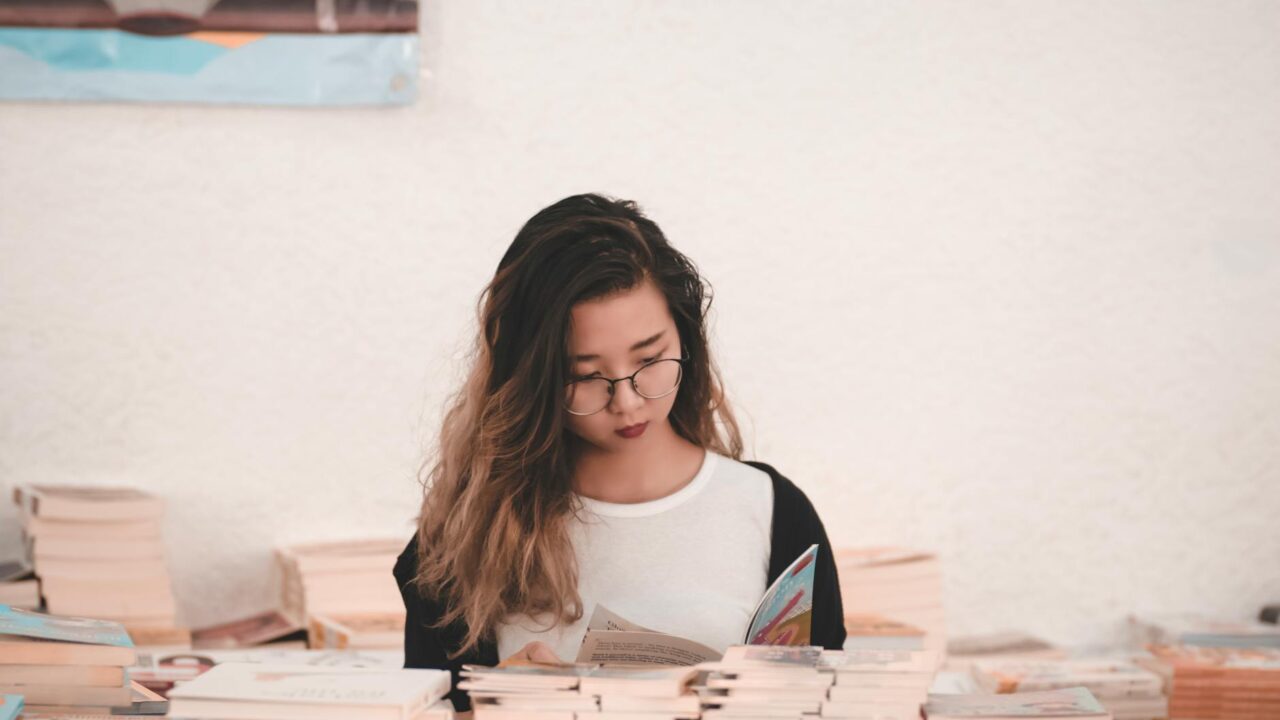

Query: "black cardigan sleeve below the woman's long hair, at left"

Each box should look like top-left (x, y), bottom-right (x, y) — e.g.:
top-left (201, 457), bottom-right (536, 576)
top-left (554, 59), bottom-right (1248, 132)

top-left (394, 536), bottom-right (498, 712)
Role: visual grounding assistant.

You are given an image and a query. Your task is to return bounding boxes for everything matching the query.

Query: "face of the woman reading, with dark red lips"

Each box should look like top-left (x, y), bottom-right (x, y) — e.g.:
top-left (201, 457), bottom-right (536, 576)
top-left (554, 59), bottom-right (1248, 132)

top-left (564, 281), bottom-right (681, 452)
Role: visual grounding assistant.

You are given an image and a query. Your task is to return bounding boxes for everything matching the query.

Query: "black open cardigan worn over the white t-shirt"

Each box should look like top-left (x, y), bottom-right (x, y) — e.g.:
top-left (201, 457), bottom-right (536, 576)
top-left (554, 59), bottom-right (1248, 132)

top-left (394, 461), bottom-right (845, 711)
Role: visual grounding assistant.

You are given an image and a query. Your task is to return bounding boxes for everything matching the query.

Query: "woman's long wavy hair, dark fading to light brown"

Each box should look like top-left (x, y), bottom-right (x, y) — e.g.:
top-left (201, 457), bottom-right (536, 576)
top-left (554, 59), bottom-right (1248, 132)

top-left (415, 195), bottom-right (742, 657)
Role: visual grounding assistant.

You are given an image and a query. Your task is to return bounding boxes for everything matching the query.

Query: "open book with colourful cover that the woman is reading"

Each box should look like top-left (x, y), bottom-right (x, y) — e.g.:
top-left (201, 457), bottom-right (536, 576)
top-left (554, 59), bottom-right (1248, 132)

top-left (576, 544), bottom-right (818, 666)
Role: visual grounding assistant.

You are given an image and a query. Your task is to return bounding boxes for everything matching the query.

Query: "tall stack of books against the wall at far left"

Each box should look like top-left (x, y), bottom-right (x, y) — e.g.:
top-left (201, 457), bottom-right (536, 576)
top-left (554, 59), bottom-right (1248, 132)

top-left (14, 486), bottom-right (189, 644)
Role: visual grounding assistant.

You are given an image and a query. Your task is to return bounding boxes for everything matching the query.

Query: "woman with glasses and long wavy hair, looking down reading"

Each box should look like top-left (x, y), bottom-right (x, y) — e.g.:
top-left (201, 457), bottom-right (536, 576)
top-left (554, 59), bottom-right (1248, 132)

top-left (396, 195), bottom-right (845, 710)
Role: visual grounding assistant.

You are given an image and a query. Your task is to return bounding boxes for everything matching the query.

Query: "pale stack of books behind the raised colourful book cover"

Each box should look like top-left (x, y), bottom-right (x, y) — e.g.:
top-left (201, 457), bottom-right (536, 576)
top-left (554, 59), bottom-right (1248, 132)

top-left (836, 547), bottom-right (947, 657)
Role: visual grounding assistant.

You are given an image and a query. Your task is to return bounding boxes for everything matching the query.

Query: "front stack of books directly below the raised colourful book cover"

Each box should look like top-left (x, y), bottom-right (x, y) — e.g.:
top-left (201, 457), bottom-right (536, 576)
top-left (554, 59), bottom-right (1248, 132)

top-left (698, 646), bottom-right (835, 719)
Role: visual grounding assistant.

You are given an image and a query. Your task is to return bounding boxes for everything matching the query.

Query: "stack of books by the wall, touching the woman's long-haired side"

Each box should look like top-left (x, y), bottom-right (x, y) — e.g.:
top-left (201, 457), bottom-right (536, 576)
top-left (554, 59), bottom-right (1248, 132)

top-left (275, 538), bottom-right (404, 625)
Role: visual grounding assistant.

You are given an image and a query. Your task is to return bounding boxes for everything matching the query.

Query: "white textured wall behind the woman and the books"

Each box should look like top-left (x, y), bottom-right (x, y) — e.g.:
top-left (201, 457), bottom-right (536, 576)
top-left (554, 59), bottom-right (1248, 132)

top-left (0, 0), bottom-right (1280, 642)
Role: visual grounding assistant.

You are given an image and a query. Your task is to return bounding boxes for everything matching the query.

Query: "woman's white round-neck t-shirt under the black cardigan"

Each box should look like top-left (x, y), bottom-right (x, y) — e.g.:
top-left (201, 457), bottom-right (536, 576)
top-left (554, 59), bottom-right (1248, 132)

top-left (498, 451), bottom-right (773, 661)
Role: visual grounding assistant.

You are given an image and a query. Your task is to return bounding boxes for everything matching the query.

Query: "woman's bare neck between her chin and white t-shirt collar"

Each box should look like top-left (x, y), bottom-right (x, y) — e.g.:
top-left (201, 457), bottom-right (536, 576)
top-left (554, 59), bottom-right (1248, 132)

top-left (573, 423), bottom-right (704, 505)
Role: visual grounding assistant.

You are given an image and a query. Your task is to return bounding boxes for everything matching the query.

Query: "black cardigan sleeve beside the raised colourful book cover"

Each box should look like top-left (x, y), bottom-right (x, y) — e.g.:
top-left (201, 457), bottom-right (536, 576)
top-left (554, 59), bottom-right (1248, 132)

top-left (748, 461), bottom-right (845, 650)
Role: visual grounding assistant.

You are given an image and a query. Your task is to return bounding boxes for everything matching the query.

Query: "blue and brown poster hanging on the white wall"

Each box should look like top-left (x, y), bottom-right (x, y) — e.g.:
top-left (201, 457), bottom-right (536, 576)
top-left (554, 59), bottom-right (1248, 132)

top-left (0, 0), bottom-right (419, 105)
